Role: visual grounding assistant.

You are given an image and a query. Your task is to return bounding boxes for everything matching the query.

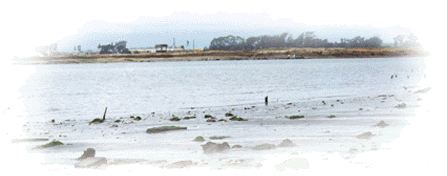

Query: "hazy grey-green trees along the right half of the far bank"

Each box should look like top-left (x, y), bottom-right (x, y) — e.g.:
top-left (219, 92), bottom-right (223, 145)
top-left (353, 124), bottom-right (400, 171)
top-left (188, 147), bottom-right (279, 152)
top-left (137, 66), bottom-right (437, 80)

top-left (209, 32), bottom-right (419, 50)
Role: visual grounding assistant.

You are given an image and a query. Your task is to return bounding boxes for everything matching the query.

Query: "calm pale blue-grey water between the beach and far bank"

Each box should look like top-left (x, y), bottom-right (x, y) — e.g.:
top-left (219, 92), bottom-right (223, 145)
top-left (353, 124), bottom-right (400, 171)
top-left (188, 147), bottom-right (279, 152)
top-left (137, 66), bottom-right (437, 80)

top-left (14, 58), bottom-right (426, 121)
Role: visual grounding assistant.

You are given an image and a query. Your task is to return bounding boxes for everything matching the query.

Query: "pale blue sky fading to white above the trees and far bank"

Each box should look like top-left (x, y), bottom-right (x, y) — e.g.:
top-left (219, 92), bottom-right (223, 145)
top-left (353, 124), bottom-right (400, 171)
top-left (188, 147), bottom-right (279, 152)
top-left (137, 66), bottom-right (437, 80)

top-left (0, 0), bottom-right (444, 57)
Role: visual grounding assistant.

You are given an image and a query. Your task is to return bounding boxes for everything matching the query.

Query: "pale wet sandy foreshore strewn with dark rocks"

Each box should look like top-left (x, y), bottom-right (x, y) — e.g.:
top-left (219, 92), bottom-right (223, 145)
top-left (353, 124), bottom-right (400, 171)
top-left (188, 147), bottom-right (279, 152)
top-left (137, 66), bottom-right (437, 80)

top-left (4, 87), bottom-right (438, 175)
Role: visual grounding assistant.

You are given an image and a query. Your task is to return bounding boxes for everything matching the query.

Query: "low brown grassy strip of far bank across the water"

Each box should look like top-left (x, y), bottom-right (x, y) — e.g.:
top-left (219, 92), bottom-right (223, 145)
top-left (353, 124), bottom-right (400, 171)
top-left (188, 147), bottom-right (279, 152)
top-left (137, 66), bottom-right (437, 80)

top-left (13, 48), bottom-right (430, 65)
